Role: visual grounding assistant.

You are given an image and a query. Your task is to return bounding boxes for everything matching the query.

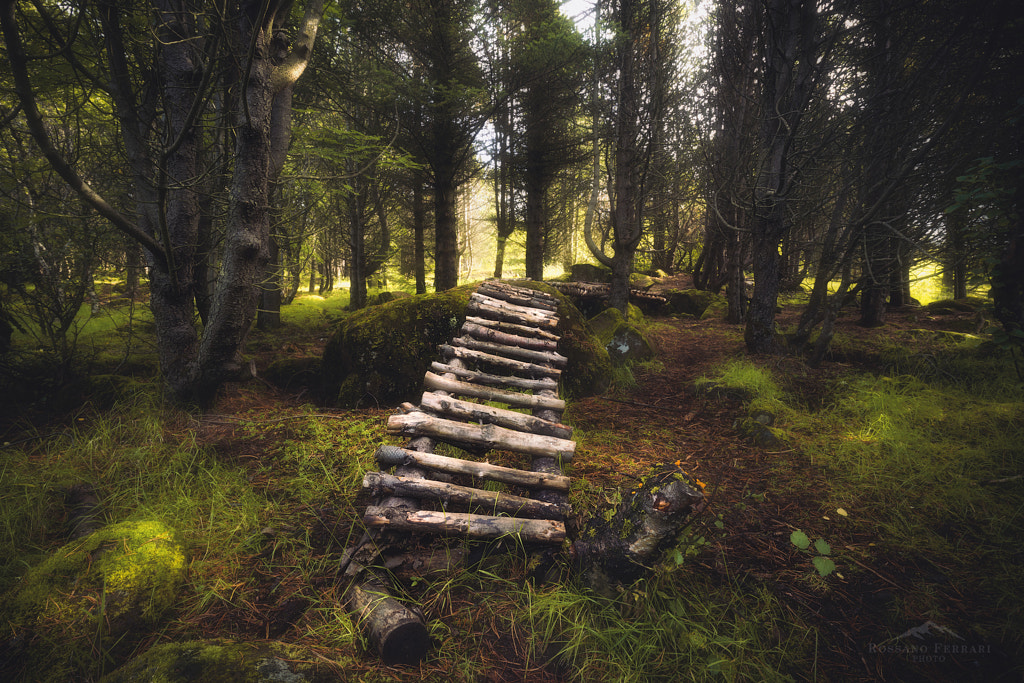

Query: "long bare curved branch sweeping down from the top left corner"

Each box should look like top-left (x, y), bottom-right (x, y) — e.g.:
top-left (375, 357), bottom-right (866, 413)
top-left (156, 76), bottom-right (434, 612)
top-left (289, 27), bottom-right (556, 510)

top-left (0, 0), bottom-right (166, 261)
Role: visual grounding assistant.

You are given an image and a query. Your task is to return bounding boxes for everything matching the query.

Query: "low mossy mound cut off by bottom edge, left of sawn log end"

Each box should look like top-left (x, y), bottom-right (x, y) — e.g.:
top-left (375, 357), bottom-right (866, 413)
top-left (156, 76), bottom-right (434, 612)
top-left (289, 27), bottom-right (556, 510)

top-left (101, 640), bottom-right (337, 683)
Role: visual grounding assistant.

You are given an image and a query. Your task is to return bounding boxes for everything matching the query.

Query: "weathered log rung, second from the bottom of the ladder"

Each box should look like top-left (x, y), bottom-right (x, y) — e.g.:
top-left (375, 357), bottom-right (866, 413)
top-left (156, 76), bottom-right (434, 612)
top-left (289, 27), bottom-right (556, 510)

top-left (362, 472), bottom-right (568, 519)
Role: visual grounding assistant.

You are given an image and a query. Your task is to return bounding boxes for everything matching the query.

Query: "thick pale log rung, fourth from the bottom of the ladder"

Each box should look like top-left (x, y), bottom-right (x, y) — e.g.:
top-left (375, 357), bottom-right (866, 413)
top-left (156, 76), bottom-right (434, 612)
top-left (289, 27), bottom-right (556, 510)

top-left (387, 413), bottom-right (575, 462)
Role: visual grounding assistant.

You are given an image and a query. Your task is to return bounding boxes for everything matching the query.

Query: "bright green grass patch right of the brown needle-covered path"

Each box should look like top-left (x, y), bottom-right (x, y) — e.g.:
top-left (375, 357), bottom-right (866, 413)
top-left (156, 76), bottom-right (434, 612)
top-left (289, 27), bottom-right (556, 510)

top-left (713, 344), bottom-right (1024, 649)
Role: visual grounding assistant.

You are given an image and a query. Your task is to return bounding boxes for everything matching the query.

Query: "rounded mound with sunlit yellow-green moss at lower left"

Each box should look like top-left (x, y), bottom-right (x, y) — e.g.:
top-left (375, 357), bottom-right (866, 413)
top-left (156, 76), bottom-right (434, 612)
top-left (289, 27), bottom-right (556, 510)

top-left (0, 521), bottom-right (185, 681)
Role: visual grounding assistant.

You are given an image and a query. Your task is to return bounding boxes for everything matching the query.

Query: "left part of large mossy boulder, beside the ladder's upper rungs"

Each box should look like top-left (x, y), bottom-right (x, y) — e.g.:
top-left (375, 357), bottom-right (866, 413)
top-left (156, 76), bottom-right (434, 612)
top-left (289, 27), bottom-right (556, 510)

top-left (323, 286), bottom-right (473, 407)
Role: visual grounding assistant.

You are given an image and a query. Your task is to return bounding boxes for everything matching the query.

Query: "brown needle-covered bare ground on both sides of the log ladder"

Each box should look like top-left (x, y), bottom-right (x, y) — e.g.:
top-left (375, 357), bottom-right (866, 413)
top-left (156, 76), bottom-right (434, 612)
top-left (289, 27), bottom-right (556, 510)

top-left (4, 274), bottom-right (1024, 683)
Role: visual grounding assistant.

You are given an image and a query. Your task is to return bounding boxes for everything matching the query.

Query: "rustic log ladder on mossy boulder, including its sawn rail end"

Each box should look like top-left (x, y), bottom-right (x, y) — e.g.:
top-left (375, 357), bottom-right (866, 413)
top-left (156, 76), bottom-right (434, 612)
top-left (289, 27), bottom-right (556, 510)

top-left (348, 281), bottom-right (575, 661)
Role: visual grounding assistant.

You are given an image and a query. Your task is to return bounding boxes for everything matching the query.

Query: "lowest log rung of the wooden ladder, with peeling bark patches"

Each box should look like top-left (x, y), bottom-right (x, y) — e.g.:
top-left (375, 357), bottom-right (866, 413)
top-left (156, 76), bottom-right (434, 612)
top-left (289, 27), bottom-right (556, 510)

top-left (362, 505), bottom-right (565, 543)
